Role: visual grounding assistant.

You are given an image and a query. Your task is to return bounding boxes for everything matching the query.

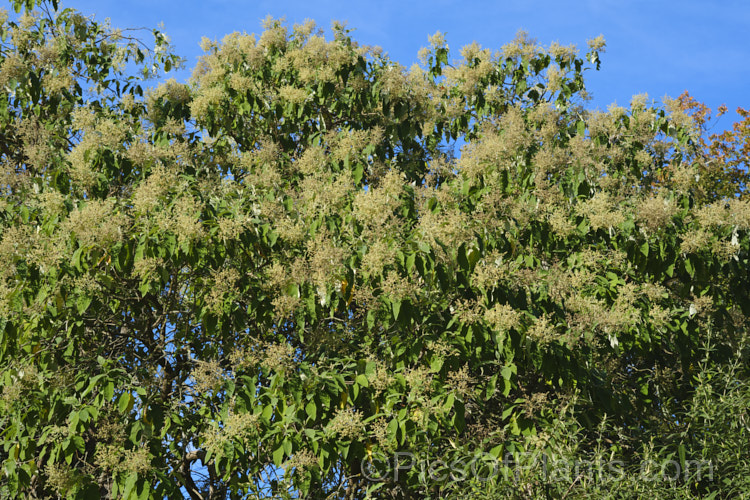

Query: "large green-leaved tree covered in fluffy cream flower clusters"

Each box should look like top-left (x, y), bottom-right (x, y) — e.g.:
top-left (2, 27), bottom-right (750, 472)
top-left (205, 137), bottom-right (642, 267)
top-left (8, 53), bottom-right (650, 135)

top-left (0, 2), bottom-right (750, 499)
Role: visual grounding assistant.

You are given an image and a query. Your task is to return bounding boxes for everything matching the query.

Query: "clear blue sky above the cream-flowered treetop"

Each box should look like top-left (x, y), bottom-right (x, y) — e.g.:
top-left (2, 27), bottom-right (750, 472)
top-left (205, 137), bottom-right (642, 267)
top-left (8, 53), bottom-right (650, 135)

top-left (72, 0), bottom-right (750, 129)
